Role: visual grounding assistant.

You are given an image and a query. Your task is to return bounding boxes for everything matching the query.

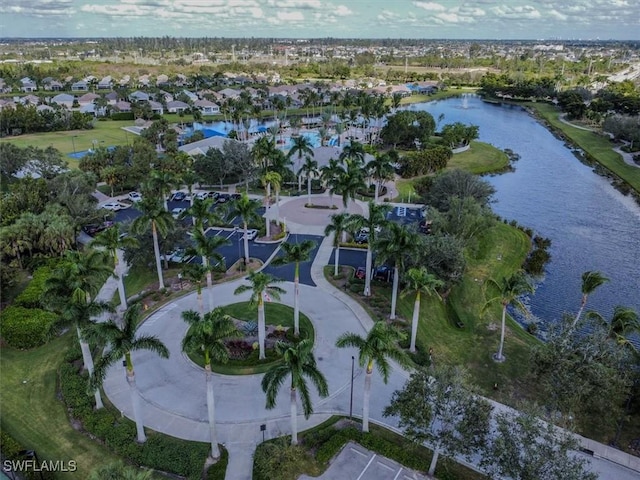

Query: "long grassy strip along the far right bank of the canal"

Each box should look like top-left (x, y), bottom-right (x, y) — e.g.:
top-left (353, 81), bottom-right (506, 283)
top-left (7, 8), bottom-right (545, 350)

top-left (526, 103), bottom-right (640, 193)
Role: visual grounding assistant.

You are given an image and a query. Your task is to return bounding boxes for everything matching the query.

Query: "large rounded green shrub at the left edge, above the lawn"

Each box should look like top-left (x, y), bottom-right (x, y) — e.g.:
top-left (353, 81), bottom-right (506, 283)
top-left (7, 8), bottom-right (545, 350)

top-left (0, 307), bottom-right (57, 348)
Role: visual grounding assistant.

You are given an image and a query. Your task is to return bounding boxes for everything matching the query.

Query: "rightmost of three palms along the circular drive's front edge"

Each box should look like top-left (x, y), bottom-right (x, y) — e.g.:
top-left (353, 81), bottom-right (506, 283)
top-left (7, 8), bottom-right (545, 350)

top-left (336, 321), bottom-right (410, 432)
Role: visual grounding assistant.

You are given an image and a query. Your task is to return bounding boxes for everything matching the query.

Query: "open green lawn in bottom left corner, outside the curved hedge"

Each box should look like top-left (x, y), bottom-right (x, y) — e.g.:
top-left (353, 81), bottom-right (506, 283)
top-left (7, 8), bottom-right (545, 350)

top-left (0, 332), bottom-right (117, 479)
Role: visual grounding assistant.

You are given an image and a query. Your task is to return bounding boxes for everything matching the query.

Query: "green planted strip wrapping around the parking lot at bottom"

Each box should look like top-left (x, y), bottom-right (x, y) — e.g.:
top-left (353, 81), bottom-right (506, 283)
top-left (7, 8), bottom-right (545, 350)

top-left (253, 417), bottom-right (486, 480)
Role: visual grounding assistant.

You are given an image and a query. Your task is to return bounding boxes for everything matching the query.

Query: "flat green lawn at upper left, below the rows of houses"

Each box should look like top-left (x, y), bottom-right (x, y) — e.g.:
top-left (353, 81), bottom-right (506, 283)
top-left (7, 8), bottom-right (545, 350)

top-left (2, 120), bottom-right (136, 156)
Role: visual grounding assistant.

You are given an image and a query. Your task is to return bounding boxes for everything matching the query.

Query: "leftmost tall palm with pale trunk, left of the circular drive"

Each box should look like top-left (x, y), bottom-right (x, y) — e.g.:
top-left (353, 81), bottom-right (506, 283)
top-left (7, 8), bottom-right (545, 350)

top-left (45, 250), bottom-right (112, 408)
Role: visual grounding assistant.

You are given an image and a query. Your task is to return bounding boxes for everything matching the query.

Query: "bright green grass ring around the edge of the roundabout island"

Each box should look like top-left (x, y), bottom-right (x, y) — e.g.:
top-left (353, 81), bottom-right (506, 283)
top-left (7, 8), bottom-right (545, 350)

top-left (188, 302), bottom-right (315, 375)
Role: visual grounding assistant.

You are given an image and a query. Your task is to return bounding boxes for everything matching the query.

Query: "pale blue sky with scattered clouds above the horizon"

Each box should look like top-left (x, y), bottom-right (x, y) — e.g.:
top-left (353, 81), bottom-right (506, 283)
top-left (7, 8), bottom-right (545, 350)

top-left (0, 0), bottom-right (640, 40)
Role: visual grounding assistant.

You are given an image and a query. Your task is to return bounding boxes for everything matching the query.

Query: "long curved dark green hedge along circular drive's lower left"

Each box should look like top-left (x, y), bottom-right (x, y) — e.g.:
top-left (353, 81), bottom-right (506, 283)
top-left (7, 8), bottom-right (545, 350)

top-left (59, 349), bottom-right (228, 480)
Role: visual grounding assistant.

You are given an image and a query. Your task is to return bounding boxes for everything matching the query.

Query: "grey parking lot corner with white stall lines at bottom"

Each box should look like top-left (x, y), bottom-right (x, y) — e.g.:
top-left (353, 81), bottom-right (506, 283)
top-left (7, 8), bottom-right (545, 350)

top-left (300, 442), bottom-right (427, 480)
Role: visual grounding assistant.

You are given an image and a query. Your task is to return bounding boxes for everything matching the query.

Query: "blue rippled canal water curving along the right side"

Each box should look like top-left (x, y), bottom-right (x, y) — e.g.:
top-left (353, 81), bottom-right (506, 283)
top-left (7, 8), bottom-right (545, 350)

top-left (409, 95), bottom-right (640, 330)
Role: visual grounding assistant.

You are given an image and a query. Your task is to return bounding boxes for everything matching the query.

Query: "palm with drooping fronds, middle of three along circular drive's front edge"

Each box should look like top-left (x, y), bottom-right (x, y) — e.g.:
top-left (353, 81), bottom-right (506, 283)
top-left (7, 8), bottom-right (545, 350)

top-left (262, 339), bottom-right (329, 445)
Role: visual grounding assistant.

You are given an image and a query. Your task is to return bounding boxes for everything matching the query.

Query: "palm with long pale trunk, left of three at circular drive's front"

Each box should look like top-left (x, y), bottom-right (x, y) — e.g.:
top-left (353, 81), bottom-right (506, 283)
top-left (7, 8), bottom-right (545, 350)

top-left (182, 307), bottom-right (240, 459)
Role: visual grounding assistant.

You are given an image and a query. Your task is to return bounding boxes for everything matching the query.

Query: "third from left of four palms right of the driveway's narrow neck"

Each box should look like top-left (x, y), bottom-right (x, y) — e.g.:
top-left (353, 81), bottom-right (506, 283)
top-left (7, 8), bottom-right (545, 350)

top-left (376, 222), bottom-right (424, 320)
